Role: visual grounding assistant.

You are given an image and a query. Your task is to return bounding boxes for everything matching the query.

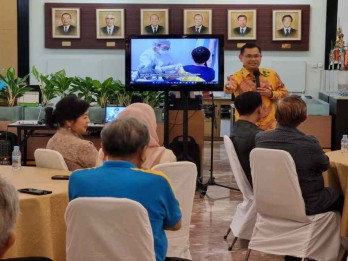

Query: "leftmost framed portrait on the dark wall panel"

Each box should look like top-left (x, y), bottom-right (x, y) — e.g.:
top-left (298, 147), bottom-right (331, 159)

top-left (52, 7), bottom-right (80, 38)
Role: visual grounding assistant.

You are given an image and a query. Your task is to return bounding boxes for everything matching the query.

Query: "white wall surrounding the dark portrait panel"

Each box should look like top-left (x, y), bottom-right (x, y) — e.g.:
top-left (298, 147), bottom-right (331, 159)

top-left (29, 0), bottom-right (326, 97)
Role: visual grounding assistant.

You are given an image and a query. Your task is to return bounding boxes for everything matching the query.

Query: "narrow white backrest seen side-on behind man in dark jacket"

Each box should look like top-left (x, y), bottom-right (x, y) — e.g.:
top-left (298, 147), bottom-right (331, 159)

top-left (224, 135), bottom-right (254, 200)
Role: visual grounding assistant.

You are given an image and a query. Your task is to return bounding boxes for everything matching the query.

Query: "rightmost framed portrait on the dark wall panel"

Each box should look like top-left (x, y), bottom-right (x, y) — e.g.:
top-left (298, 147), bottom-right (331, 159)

top-left (272, 10), bottom-right (302, 41)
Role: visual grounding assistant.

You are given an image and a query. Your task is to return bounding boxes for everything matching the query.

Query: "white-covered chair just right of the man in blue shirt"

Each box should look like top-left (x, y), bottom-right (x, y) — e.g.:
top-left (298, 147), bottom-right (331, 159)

top-left (152, 161), bottom-right (197, 260)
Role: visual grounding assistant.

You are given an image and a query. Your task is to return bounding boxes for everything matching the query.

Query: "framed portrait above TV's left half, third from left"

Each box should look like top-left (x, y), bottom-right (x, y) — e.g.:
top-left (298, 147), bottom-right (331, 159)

top-left (140, 9), bottom-right (169, 35)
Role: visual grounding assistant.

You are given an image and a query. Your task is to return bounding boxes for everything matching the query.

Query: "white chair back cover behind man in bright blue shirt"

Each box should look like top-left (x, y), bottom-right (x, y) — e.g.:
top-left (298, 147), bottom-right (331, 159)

top-left (65, 197), bottom-right (156, 261)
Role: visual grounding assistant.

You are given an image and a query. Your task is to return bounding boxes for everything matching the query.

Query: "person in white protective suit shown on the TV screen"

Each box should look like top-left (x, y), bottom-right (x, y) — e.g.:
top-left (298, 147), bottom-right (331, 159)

top-left (137, 39), bottom-right (174, 79)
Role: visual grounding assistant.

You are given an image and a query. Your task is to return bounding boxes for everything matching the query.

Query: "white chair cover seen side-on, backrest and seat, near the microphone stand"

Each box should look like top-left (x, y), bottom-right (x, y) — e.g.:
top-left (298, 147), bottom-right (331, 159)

top-left (224, 135), bottom-right (256, 240)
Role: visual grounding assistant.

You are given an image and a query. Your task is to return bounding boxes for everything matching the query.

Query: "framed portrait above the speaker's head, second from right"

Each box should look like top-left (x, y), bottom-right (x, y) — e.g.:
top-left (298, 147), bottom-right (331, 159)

top-left (227, 9), bottom-right (257, 40)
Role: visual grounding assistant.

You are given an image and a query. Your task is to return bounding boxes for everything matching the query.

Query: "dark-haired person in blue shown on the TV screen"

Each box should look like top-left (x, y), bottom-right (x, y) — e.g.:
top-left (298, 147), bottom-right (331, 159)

top-left (181, 46), bottom-right (215, 82)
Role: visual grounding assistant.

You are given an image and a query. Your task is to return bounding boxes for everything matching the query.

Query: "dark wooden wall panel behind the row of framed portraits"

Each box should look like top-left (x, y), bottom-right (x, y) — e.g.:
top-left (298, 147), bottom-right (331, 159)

top-left (45, 3), bottom-right (310, 51)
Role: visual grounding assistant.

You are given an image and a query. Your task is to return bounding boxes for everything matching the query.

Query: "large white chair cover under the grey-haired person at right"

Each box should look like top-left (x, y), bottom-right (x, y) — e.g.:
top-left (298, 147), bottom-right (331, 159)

top-left (249, 148), bottom-right (340, 261)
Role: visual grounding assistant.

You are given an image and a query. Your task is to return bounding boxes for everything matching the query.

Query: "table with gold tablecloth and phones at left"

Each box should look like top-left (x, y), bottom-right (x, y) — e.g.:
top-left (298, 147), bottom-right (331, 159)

top-left (0, 166), bottom-right (70, 261)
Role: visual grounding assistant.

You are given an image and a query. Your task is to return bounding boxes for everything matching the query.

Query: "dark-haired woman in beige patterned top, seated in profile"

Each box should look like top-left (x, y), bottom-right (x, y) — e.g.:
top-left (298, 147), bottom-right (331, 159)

top-left (46, 95), bottom-right (98, 171)
